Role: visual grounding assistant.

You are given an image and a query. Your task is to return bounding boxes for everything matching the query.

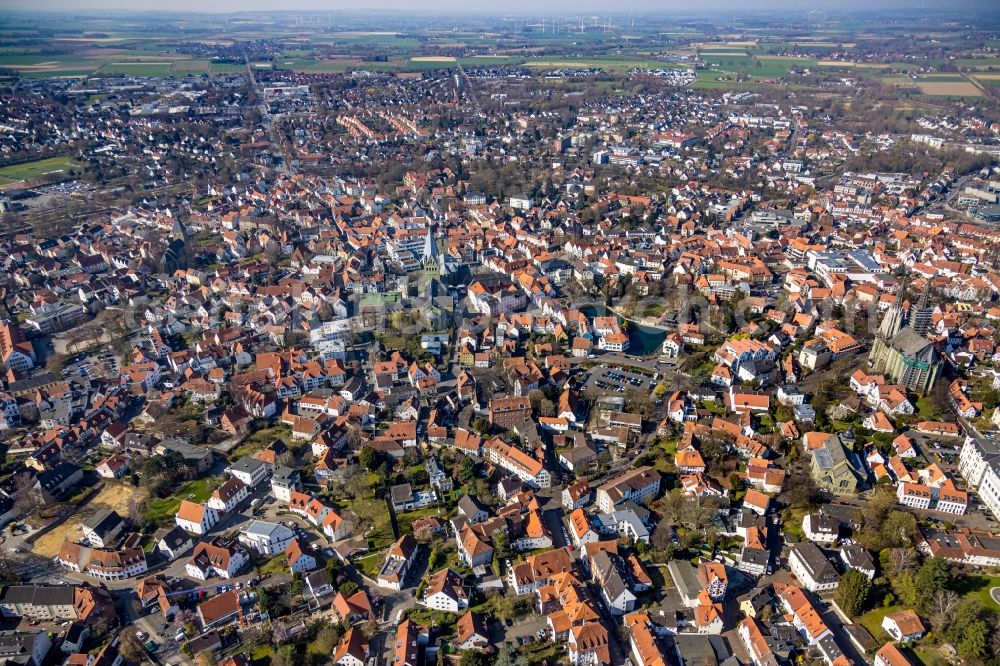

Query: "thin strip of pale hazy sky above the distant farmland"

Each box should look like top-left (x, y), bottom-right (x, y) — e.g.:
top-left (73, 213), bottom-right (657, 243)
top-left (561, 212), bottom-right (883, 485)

top-left (0, 0), bottom-right (1000, 15)
